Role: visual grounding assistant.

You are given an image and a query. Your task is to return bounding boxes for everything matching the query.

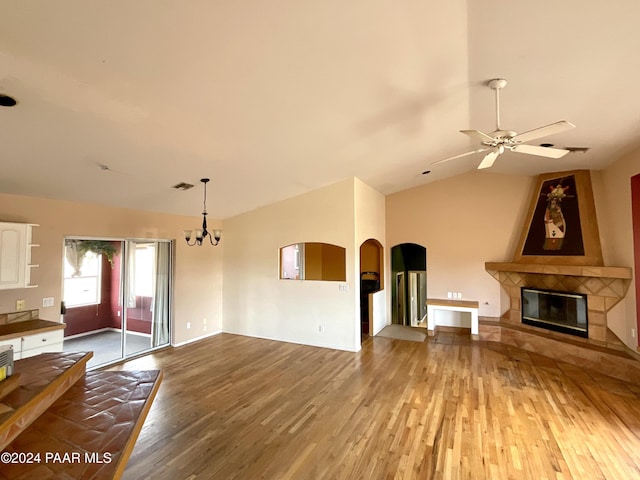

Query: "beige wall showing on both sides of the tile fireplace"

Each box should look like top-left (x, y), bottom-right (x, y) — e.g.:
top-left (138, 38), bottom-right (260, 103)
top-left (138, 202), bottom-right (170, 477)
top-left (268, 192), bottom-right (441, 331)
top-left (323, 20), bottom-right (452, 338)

top-left (386, 161), bottom-right (640, 348)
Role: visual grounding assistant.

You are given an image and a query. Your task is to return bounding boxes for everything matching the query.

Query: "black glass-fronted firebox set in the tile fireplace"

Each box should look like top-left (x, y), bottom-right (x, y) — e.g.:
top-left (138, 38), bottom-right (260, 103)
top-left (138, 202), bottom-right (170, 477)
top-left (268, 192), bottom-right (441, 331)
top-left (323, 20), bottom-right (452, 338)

top-left (520, 287), bottom-right (589, 338)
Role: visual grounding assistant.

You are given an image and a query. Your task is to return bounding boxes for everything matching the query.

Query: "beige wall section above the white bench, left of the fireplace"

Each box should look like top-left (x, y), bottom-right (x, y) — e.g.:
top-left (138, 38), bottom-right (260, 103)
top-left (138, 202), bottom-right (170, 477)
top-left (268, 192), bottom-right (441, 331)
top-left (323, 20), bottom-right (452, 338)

top-left (386, 170), bottom-right (535, 317)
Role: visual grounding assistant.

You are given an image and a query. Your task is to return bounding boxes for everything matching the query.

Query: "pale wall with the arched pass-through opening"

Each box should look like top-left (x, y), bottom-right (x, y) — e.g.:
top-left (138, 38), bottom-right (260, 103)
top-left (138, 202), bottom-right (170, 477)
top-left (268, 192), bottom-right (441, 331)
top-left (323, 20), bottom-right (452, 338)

top-left (223, 179), bottom-right (360, 351)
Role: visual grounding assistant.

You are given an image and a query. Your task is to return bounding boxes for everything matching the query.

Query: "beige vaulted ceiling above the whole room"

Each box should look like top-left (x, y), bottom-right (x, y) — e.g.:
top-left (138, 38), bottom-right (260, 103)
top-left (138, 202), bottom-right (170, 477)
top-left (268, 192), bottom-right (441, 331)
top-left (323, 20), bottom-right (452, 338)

top-left (0, 0), bottom-right (640, 218)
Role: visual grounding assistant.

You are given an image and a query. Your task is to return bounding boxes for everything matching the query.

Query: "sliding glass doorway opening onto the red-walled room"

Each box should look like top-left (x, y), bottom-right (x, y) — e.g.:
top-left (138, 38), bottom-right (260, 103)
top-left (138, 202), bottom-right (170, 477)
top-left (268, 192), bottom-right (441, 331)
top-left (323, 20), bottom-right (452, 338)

top-left (62, 237), bottom-right (171, 368)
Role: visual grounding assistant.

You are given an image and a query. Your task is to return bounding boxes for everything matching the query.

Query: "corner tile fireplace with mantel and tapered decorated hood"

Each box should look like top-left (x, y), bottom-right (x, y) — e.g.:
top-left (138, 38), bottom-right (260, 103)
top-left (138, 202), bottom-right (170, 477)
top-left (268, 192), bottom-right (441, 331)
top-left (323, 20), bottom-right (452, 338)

top-left (485, 170), bottom-right (632, 346)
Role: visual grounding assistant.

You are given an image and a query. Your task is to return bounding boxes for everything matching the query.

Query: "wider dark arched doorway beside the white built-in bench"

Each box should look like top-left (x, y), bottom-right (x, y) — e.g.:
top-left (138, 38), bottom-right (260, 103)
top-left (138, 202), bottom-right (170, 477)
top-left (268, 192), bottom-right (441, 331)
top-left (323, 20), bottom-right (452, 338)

top-left (391, 243), bottom-right (427, 328)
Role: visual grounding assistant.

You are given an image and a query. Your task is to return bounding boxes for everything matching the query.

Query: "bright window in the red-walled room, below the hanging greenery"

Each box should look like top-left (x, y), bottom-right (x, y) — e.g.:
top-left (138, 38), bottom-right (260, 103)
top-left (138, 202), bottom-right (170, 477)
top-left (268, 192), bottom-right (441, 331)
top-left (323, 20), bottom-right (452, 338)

top-left (64, 247), bottom-right (102, 307)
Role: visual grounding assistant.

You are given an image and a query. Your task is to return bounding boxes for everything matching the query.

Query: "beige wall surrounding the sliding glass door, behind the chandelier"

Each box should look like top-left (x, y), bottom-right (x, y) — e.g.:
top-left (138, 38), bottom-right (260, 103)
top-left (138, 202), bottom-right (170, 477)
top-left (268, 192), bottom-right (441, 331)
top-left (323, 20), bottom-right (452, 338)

top-left (0, 194), bottom-right (224, 343)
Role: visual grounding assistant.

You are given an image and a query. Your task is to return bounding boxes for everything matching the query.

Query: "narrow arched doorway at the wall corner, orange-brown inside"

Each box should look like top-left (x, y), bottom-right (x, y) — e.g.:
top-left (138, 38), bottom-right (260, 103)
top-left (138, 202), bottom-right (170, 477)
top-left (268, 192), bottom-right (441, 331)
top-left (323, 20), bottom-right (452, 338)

top-left (360, 238), bottom-right (384, 337)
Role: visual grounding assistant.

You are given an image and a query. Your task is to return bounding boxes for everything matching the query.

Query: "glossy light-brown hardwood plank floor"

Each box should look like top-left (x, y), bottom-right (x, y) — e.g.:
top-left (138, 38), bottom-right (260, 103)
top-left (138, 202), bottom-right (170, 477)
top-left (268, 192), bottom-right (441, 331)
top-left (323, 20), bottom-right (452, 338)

top-left (111, 333), bottom-right (640, 480)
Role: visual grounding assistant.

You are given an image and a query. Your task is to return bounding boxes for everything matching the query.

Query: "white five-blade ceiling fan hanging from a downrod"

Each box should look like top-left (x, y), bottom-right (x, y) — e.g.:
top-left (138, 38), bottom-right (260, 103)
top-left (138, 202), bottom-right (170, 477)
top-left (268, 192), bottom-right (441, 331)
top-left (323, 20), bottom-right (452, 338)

top-left (432, 78), bottom-right (575, 169)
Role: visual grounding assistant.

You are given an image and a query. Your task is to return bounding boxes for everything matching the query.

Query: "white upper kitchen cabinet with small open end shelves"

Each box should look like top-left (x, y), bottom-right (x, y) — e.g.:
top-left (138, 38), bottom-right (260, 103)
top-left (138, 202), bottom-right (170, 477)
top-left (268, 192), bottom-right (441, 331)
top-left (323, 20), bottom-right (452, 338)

top-left (0, 222), bottom-right (38, 289)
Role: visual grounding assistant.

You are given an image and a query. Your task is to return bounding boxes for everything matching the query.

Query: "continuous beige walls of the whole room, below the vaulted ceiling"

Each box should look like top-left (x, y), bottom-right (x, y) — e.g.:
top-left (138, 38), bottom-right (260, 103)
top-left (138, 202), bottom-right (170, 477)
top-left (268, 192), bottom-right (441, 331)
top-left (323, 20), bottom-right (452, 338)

top-left (7, 158), bottom-right (640, 350)
